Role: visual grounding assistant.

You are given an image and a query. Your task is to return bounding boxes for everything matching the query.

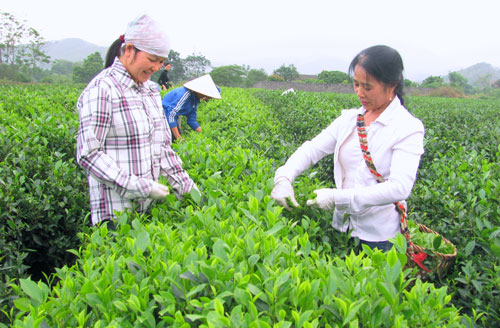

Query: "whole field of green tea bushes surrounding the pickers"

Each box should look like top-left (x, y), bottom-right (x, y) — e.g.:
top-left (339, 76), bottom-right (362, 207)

top-left (0, 85), bottom-right (500, 327)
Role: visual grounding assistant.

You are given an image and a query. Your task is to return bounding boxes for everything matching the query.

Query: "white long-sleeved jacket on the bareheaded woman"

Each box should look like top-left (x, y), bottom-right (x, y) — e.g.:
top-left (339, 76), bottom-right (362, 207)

top-left (274, 97), bottom-right (424, 241)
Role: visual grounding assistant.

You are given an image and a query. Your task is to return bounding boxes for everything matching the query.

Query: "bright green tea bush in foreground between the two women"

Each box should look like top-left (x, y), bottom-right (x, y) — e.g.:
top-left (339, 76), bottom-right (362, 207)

top-left (5, 135), bottom-right (466, 327)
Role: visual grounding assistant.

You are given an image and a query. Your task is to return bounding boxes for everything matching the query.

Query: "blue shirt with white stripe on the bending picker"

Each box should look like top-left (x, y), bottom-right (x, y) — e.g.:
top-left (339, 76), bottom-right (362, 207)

top-left (162, 87), bottom-right (200, 130)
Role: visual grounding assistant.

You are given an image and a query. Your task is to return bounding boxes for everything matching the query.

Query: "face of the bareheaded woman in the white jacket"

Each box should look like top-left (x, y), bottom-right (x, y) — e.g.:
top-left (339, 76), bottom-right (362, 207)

top-left (353, 65), bottom-right (396, 111)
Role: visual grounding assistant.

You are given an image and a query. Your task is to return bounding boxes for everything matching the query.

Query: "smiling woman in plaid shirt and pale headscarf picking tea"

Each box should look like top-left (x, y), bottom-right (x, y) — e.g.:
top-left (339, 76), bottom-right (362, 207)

top-left (76, 15), bottom-right (198, 227)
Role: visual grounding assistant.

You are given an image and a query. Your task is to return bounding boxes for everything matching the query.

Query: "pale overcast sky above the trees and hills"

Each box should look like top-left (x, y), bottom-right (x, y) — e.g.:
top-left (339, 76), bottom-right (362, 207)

top-left (0, 0), bottom-right (500, 81)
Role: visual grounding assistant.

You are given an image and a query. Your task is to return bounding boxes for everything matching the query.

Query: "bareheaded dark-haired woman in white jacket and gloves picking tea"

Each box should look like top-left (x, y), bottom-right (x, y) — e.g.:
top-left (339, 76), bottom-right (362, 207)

top-left (271, 46), bottom-right (424, 251)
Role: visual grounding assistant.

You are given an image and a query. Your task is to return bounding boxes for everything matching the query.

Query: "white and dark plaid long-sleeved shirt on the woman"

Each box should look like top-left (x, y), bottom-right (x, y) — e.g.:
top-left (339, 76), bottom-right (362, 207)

top-left (76, 59), bottom-right (194, 224)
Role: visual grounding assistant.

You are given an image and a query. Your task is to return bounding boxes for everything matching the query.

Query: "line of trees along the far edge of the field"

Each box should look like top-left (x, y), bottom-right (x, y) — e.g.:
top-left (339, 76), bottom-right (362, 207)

top-left (0, 12), bottom-right (500, 96)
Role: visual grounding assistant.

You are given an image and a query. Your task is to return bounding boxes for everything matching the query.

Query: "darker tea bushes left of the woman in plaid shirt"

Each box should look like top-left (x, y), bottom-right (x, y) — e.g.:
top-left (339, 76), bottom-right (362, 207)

top-left (0, 85), bottom-right (89, 322)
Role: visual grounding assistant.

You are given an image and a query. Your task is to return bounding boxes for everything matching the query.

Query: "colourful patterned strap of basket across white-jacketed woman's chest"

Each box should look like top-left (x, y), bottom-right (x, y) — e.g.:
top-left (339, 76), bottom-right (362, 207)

top-left (356, 114), bottom-right (430, 272)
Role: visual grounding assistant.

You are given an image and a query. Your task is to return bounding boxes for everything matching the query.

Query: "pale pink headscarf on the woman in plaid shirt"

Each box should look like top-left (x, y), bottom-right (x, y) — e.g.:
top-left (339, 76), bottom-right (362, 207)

top-left (125, 15), bottom-right (170, 58)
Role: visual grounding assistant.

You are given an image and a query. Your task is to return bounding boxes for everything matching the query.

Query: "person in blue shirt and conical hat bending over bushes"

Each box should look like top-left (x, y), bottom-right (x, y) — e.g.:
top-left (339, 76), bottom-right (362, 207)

top-left (162, 74), bottom-right (221, 140)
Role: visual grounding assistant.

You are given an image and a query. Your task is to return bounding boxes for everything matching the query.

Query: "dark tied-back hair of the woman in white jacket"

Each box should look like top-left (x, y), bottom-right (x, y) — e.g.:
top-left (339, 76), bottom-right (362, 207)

top-left (349, 45), bottom-right (404, 105)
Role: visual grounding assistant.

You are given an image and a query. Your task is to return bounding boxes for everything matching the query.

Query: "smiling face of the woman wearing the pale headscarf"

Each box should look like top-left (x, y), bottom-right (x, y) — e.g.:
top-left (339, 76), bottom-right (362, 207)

top-left (122, 44), bottom-right (165, 83)
